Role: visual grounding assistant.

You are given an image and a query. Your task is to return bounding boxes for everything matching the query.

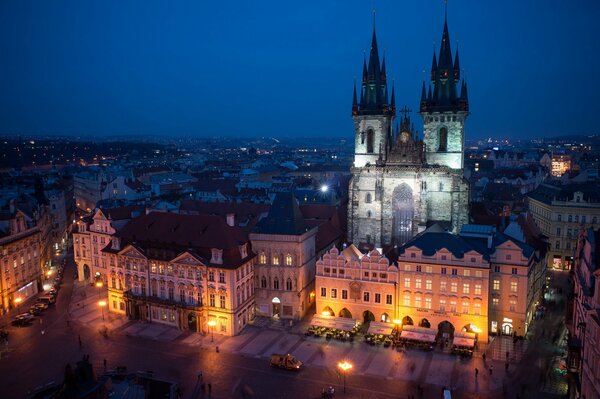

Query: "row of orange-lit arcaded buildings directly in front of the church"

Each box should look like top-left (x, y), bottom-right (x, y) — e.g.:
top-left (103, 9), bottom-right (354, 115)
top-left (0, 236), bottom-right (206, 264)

top-left (316, 225), bottom-right (534, 342)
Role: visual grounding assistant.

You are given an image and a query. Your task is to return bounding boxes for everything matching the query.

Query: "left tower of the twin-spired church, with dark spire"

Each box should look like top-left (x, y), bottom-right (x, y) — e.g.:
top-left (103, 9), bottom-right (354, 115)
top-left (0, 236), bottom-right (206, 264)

top-left (352, 27), bottom-right (396, 168)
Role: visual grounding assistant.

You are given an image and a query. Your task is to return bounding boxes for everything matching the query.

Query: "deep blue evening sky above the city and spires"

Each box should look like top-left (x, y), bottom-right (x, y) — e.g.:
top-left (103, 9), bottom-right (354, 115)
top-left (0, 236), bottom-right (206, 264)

top-left (0, 0), bottom-right (600, 138)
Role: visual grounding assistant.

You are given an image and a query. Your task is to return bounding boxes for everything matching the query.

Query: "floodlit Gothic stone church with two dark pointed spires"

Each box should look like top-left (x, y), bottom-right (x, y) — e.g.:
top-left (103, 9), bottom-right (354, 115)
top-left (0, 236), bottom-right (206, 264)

top-left (348, 14), bottom-right (469, 247)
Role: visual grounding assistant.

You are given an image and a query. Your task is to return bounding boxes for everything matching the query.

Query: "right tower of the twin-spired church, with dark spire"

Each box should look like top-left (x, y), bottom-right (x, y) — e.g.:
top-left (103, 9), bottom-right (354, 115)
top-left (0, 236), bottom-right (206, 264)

top-left (420, 10), bottom-right (469, 170)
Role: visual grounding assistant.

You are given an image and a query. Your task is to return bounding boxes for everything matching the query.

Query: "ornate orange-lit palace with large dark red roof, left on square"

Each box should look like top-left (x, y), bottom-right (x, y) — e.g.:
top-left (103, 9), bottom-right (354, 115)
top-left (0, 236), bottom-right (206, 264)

top-left (76, 211), bottom-right (255, 335)
